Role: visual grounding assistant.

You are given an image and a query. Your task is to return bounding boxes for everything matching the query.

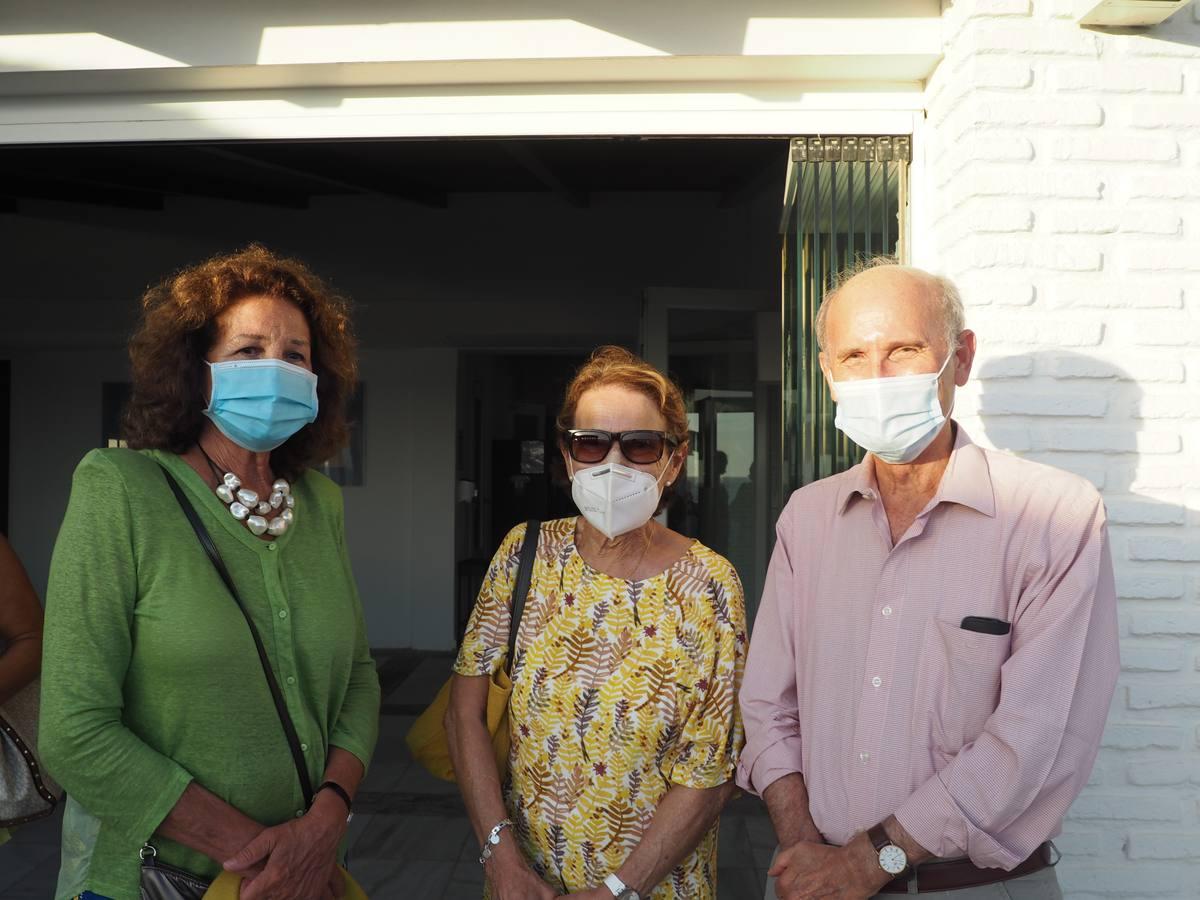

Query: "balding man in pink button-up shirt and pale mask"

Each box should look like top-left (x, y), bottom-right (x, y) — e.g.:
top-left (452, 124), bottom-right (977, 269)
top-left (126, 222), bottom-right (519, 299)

top-left (738, 264), bottom-right (1120, 900)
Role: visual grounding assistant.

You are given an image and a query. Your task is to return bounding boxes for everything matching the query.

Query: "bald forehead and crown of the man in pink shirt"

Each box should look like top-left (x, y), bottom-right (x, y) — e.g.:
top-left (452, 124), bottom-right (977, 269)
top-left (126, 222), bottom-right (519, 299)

top-left (816, 258), bottom-right (965, 353)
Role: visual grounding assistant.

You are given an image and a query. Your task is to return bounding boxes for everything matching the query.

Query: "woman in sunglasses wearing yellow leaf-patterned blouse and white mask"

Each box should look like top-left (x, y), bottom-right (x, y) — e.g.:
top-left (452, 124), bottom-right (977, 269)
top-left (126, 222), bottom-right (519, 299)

top-left (446, 347), bottom-right (746, 900)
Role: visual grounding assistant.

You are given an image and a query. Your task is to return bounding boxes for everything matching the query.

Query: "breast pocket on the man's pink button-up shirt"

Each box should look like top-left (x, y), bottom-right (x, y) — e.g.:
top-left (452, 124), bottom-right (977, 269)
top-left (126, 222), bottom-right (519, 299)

top-left (912, 619), bottom-right (1012, 770)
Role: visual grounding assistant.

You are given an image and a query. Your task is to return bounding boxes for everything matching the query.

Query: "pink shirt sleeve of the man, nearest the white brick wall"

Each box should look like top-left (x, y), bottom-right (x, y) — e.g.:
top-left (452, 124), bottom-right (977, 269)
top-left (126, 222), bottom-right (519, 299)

top-left (895, 498), bottom-right (1120, 870)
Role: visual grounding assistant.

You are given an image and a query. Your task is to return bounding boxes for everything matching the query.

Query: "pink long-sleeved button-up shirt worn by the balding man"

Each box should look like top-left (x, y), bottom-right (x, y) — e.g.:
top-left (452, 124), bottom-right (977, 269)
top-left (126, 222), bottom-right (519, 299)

top-left (737, 427), bottom-right (1120, 869)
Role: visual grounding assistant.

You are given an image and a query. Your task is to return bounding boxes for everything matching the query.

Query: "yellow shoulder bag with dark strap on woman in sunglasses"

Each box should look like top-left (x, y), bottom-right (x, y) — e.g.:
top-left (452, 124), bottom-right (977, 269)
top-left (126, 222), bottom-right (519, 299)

top-left (404, 520), bottom-right (541, 781)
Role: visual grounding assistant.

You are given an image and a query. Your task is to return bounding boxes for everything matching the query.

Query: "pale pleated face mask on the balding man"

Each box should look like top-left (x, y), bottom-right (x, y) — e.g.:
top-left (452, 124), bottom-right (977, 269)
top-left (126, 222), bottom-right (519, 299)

top-left (830, 353), bottom-right (954, 464)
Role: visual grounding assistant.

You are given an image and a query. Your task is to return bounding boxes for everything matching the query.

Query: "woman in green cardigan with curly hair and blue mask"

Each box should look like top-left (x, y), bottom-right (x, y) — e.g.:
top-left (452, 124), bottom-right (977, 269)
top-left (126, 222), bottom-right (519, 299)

top-left (40, 246), bottom-right (379, 900)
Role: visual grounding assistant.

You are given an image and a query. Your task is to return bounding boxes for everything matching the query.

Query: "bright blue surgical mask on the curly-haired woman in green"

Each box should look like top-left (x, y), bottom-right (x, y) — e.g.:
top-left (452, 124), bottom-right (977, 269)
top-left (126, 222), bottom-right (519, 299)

top-left (204, 359), bottom-right (317, 454)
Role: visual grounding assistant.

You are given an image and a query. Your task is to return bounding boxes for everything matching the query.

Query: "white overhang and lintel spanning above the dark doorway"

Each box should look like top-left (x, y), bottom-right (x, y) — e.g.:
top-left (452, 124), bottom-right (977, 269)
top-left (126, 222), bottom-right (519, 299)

top-left (0, 9), bottom-right (942, 143)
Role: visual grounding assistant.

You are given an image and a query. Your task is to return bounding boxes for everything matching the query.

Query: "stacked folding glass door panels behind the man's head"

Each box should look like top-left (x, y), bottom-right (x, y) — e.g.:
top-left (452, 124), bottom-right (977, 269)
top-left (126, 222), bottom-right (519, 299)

top-left (780, 136), bottom-right (912, 493)
